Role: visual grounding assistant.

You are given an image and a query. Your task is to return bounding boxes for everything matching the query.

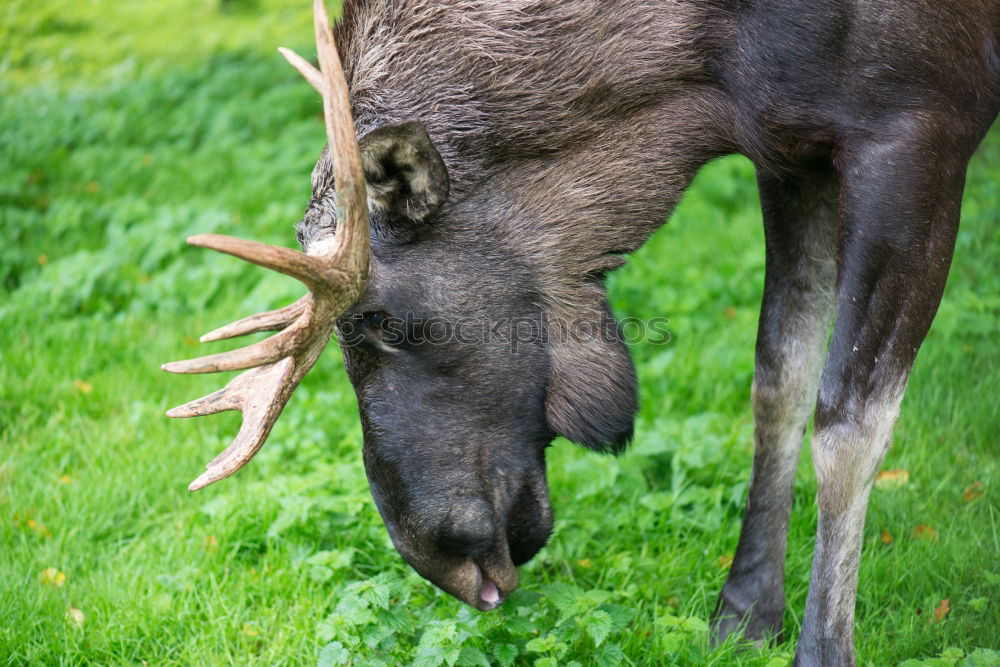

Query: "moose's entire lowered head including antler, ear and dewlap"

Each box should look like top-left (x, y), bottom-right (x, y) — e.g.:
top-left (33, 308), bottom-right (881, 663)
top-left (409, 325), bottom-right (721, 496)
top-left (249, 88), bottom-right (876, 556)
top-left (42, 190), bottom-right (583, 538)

top-left (163, 0), bottom-right (636, 610)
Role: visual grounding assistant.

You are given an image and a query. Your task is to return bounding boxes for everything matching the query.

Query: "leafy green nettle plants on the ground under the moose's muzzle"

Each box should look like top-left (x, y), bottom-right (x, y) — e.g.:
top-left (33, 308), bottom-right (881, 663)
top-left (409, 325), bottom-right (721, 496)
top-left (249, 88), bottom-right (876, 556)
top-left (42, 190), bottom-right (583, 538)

top-left (319, 576), bottom-right (708, 667)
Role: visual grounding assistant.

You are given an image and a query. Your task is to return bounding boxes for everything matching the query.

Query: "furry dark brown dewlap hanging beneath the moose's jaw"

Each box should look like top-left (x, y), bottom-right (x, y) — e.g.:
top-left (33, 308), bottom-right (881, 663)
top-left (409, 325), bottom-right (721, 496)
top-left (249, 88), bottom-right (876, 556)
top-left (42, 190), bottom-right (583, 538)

top-left (545, 295), bottom-right (638, 454)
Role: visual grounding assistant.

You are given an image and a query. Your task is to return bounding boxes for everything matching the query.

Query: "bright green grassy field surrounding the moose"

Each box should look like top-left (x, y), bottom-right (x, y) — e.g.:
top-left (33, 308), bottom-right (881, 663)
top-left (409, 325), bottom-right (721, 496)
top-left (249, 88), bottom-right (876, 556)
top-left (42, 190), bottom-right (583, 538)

top-left (0, 0), bottom-right (1000, 667)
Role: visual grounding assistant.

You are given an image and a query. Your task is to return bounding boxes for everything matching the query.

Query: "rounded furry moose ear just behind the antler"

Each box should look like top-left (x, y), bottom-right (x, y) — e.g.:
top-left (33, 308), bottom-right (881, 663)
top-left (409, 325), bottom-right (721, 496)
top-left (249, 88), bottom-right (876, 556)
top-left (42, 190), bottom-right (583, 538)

top-left (360, 121), bottom-right (448, 230)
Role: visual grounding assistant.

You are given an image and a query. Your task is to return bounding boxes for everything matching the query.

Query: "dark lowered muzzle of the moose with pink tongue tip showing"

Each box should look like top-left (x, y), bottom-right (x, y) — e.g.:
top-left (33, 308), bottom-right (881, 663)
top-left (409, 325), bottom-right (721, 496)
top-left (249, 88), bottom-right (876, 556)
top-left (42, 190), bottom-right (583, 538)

top-left (365, 423), bottom-right (552, 611)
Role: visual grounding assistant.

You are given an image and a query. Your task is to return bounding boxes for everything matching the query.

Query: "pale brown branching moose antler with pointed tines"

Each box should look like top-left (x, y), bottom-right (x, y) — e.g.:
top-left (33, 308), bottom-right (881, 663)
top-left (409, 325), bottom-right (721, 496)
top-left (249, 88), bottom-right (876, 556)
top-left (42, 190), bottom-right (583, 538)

top-left (162, 0), bottom-right (369, 491)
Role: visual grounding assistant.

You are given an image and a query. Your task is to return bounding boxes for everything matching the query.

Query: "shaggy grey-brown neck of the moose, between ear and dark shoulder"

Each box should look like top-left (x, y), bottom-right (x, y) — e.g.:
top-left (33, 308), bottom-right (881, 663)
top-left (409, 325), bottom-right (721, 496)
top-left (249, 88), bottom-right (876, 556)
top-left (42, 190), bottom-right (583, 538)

top-left (337, 0), bottom-right (732, 274)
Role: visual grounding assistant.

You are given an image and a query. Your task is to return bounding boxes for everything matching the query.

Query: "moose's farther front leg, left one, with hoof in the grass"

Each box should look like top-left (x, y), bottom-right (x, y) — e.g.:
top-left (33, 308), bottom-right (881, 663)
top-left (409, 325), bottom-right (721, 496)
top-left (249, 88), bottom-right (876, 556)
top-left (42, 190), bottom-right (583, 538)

top-left (713, 170), bottom-right (838, 641)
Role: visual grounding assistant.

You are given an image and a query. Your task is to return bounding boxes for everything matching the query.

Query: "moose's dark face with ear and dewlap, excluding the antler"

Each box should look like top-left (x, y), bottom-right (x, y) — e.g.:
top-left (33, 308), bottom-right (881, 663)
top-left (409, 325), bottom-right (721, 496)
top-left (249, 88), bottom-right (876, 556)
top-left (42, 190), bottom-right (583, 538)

top-left (298, 123), bottom-right (636, 610)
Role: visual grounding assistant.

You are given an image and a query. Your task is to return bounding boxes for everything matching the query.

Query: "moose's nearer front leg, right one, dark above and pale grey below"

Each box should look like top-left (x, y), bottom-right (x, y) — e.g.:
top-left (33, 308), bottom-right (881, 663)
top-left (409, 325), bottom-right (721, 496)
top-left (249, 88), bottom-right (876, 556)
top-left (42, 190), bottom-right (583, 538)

top-left (795, 128), bottom-right (972, 667)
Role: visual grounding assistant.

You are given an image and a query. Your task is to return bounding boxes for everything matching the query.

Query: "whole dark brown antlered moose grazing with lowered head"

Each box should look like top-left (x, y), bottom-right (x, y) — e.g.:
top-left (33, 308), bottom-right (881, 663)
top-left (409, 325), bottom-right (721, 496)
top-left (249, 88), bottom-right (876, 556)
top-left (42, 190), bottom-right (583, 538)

top-left (164, 0), bottom-right (1000, 666)
